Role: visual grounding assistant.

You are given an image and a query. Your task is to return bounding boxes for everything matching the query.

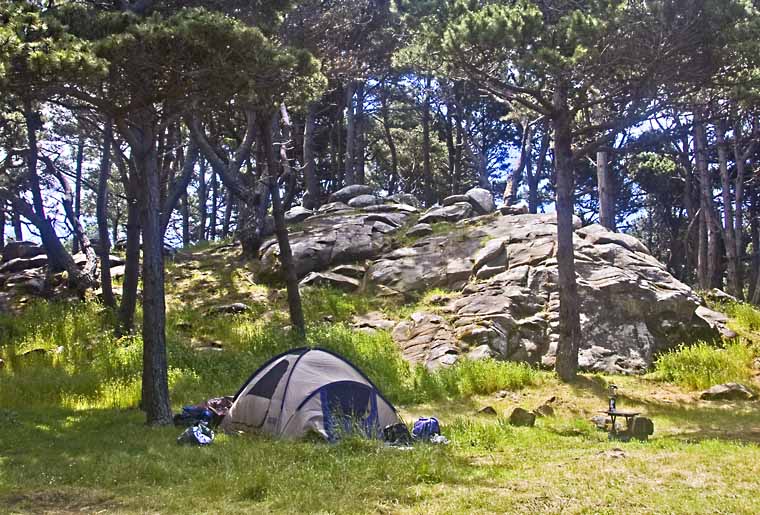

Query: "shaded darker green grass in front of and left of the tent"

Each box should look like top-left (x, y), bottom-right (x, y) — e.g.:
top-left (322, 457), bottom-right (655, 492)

top-left (0, 408), bottom-right (470, 513)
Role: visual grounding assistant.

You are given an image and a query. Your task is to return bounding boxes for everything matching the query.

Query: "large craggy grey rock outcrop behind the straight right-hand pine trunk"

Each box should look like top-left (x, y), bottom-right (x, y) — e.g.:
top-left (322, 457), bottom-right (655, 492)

top-left (365, 212), bottom-right (718, 373)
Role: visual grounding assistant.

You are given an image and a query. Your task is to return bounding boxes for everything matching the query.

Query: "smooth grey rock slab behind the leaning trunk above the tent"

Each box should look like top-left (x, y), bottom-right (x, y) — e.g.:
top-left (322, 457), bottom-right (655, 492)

top-left (261, 206), bottom-right (411, 278)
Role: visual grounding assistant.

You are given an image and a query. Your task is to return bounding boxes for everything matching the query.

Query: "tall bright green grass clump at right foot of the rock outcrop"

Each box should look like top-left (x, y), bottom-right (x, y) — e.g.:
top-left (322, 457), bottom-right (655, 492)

top-left (654, 342), bottom-right (753, 390)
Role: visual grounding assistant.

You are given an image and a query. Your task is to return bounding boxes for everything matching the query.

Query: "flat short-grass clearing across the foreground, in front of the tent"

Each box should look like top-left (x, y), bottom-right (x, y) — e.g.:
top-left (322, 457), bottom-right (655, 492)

top-left (0, 374), bottom-right (760, 514)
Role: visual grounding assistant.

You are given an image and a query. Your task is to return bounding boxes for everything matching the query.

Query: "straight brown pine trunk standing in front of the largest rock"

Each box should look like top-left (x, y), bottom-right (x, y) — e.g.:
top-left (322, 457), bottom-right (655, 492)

top-left (552, 80), bottom-right (581, 381)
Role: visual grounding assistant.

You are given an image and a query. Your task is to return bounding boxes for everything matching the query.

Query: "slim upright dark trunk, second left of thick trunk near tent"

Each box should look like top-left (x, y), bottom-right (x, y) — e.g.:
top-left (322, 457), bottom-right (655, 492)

top-left (95, 118), bottom-right (116, 308)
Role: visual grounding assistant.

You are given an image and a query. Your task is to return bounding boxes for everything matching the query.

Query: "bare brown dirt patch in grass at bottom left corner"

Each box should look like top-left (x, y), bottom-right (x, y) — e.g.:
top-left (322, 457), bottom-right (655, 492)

top-left (0, 489), bottom-right (119, 515)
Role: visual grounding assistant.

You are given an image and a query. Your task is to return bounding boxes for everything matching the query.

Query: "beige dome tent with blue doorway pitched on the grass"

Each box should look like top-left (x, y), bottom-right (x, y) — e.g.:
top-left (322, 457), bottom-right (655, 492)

top-left (221, 348), bottom-right (401, 442)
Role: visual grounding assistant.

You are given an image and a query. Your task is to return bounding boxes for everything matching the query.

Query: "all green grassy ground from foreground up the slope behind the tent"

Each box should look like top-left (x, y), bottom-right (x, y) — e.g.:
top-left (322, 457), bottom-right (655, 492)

top-left (0, 243), bottom-right (760, 514)
